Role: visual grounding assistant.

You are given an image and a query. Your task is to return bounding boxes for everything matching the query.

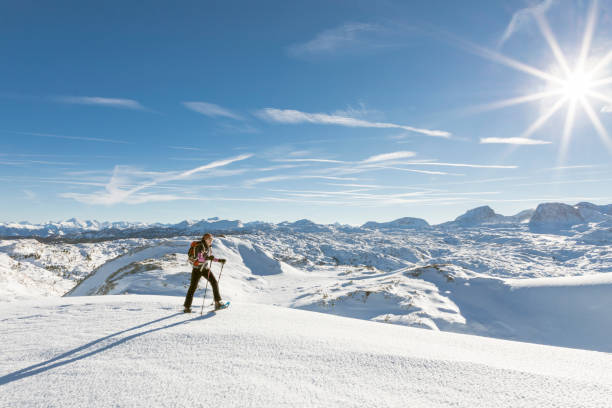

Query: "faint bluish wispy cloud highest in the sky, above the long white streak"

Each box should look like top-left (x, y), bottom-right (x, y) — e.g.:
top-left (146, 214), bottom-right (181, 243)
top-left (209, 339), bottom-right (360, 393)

top-left (287, 23), bottom-right (383, 57)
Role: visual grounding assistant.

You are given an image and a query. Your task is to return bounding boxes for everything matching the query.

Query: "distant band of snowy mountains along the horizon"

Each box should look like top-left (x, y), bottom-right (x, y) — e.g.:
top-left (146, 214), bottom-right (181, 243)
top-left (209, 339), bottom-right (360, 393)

top-left (0, 202), bottom-right (612, 240)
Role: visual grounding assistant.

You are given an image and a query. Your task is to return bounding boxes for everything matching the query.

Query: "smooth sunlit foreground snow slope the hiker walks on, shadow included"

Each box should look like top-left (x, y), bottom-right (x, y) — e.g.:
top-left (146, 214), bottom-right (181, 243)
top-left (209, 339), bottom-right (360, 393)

top-left (0, 296), bottom-right (612, 408)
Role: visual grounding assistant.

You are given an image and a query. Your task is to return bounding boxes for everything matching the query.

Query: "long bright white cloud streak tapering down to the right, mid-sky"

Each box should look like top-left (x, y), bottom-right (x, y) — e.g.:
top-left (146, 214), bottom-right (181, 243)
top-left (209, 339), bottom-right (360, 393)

top-left (257, 108), bottom-right (451, 138)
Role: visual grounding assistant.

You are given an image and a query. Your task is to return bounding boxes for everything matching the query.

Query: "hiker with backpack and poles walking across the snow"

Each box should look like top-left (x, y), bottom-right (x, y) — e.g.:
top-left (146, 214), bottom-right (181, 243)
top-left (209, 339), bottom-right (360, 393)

top-left (183, 234), bottom-right (226, 313)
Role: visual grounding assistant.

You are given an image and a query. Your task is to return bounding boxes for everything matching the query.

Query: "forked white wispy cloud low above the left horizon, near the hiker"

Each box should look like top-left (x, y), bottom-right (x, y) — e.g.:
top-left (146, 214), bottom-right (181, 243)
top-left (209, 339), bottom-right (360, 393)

top-left (60, 154), bottom-right (252, 205)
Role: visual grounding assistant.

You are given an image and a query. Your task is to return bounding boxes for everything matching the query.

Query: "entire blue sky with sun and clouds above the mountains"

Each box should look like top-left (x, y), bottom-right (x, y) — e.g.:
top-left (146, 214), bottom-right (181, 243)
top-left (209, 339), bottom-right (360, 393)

top-left (0, 0), bottom-right (612, 224)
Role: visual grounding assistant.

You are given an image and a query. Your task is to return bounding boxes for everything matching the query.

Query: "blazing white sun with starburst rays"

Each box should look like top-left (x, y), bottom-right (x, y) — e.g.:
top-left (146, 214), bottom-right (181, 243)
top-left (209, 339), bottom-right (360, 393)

top-left (463, 0), bottom-right (612, 162)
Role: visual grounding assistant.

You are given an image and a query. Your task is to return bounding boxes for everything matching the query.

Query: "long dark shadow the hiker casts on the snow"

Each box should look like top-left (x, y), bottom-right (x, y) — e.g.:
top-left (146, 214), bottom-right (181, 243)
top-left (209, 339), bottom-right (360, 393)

top-left (0, 311), bottom-right (215, 385)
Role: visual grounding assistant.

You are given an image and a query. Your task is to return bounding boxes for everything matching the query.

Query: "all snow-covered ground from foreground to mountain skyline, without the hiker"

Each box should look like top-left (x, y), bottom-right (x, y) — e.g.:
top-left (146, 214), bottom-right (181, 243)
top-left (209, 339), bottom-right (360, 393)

top-left (0, 203), bottom-right (612, 407)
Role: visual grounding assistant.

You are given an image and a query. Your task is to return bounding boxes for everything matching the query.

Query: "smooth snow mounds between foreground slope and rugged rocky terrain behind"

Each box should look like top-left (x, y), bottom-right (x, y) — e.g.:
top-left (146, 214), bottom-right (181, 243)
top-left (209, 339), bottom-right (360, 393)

top-left (53, 236), bottom-right (612, 352)
